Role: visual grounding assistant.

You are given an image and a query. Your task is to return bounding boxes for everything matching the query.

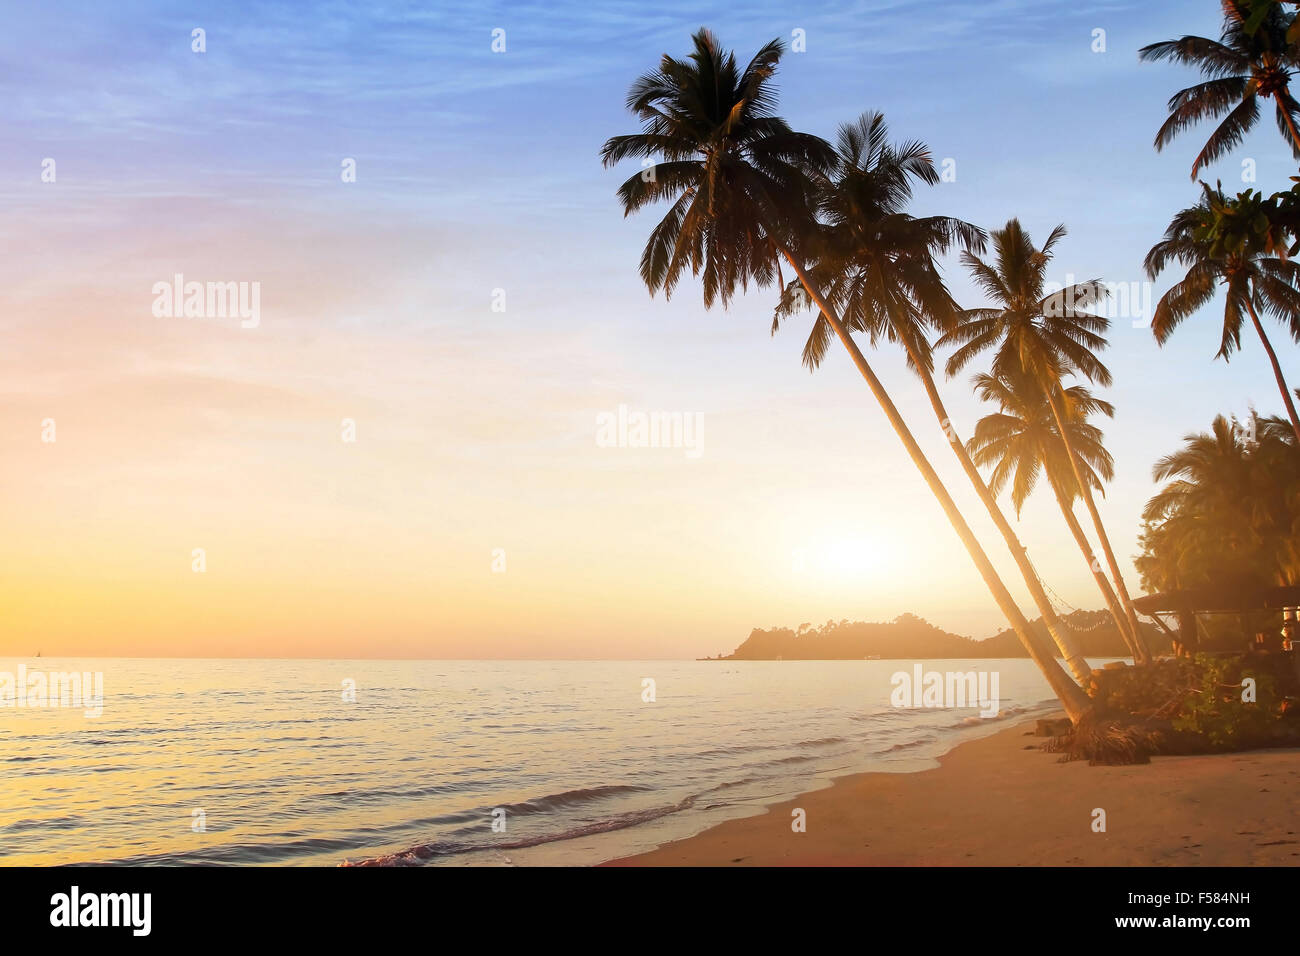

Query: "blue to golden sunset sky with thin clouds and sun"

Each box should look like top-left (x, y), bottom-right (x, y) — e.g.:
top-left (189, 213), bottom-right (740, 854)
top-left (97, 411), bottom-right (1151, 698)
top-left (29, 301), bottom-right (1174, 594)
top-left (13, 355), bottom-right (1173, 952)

top-left (0, 0), bottom-right (1300, 658)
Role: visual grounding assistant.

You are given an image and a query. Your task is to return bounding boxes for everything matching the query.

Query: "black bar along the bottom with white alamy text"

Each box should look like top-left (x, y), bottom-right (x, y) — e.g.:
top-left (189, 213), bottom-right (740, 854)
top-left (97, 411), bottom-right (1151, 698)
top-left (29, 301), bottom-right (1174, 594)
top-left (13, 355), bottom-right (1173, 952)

top-left (0, 866), bottom-right (1279, 952)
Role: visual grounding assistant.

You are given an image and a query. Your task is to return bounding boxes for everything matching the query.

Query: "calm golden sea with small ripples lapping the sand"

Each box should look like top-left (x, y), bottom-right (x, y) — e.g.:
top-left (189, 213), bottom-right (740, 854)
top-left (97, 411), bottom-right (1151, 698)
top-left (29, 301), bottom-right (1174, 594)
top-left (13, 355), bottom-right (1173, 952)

top-left (0, 658), bottom-right (1076, 865)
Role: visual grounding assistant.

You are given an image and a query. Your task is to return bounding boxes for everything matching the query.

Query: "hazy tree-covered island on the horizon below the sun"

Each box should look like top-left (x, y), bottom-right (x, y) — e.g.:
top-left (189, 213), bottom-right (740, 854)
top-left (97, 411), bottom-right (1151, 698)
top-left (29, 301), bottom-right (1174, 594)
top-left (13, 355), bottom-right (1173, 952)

top-left (699, 610), bottom-right (1169, 661)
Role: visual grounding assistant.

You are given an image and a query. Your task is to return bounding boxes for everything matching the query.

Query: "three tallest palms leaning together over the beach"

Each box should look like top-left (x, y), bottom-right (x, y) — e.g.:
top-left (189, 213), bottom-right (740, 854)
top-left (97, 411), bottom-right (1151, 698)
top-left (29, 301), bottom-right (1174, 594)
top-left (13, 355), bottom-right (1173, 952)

top-left (602, 30), bottom-right (1147, 722)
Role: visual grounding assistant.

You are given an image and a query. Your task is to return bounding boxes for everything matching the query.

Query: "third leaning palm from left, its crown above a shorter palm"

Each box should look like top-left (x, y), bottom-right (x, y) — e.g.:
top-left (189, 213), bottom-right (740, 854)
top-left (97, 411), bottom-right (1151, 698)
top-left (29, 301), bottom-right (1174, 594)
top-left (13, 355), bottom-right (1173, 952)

top-left (937, 219), bottom-right (1143, 660)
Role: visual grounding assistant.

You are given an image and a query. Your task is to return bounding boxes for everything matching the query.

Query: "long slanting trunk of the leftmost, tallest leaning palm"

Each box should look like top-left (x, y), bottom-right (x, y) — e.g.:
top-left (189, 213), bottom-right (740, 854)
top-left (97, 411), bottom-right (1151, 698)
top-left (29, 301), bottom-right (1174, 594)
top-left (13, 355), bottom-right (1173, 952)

top-left (777, 247), bottom-right (1093, 726)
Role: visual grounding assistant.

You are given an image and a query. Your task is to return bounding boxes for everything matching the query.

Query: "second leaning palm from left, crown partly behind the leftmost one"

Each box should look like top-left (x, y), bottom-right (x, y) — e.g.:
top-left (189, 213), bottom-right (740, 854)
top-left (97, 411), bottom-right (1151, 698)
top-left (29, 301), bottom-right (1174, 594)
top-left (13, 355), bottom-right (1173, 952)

top-left (772, 113), bottom-right (1091, 683)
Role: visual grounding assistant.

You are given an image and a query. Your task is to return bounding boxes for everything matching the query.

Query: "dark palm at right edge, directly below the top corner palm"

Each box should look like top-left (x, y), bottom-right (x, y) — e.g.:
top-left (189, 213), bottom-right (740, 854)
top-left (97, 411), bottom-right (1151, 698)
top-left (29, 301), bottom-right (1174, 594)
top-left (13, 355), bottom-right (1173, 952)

top-left (1145, 183), bottom-right (1300, 441)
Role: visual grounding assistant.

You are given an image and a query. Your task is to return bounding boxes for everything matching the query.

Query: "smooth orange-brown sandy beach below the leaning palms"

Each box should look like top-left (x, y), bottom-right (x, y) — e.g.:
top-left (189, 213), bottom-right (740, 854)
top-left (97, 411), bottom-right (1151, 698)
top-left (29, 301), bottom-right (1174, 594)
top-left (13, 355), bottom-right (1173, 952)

top-left (606, 721), bottom-right (1300, 866)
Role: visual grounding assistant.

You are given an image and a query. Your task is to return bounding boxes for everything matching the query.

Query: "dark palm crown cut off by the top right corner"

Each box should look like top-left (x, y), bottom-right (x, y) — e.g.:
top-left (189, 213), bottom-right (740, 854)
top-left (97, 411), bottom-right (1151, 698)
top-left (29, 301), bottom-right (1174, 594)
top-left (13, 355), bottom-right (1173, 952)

top-left (1138, 0), bottom-right (1300, 179)
